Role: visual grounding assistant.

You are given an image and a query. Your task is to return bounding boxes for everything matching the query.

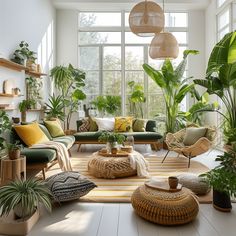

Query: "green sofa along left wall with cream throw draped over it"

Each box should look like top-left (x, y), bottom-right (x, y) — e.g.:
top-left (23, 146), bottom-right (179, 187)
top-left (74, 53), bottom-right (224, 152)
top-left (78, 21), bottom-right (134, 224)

top-left (10, 124), bottom-right (75, 178)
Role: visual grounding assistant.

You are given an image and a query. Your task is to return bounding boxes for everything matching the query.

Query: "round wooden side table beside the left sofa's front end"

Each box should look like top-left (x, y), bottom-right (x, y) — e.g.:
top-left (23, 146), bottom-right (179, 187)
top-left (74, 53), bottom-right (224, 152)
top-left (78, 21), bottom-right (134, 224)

top-left (1, 156), bottom-right (26, 185)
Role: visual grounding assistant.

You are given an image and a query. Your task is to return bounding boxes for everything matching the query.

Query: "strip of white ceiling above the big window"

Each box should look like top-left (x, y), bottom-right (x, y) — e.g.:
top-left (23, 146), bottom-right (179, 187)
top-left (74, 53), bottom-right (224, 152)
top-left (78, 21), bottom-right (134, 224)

top-left (52, 0), bottom-right (210, 11)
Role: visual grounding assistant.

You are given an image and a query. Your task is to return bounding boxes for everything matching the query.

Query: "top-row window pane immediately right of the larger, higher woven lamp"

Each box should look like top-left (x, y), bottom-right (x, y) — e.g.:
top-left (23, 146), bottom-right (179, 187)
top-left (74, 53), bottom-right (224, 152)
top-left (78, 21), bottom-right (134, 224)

top-left (165, 13), bottom-right (188, 27)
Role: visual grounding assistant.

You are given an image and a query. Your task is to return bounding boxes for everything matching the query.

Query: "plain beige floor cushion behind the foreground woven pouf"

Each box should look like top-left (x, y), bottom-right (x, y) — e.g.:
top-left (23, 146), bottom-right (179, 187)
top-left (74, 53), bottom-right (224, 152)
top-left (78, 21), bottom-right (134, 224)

top-left (178, 173), bottom-right (210, 195)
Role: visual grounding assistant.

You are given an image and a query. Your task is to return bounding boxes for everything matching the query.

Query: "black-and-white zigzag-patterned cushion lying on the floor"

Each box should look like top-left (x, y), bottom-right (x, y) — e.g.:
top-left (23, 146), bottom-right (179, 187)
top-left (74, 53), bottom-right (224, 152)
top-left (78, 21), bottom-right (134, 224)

top-left (46, 171), bottom-right (97, 202)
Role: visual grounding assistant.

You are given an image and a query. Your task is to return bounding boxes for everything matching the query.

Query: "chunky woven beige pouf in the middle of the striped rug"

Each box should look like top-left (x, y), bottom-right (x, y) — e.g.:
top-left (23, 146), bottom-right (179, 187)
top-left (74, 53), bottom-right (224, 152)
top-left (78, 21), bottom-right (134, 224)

top-left (88, 155), bottom-right (137, 179)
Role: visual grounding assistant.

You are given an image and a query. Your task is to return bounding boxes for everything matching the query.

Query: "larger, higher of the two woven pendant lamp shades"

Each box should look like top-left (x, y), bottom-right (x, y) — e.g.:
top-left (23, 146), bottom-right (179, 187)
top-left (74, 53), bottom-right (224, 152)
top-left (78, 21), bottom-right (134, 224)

top-left (129, 1), bottom-right (165, 37)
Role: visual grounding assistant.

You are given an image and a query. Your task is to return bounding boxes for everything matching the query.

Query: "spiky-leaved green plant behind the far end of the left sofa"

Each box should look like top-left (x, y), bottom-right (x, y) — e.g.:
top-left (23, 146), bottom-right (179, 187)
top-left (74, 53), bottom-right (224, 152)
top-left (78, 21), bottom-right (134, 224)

top-left (45, 94), bottom-right (65, 121)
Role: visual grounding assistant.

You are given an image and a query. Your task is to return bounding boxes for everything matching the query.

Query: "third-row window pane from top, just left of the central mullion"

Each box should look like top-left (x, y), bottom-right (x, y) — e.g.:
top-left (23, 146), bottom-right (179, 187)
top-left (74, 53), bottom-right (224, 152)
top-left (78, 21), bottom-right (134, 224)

top-left (103, 47), bottom-right (121, 70)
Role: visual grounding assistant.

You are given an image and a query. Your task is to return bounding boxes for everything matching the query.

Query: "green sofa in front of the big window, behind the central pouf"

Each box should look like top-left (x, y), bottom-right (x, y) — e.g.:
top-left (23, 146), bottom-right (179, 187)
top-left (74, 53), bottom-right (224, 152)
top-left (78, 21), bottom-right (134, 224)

top-left (74, 120), bottom-right (162, 151)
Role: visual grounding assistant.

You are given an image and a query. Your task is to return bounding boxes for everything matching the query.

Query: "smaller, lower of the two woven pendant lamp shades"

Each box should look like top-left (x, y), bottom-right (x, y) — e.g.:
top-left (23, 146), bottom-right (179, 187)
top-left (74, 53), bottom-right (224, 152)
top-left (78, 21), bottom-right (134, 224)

top-left (149, 32), bottom-right (179, 59)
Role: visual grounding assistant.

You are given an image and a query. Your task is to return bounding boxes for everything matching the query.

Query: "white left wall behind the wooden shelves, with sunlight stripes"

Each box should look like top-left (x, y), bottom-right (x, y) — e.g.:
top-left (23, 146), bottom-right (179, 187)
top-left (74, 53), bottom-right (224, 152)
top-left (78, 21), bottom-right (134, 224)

top-left (0, 0), bottom-right (56, 120)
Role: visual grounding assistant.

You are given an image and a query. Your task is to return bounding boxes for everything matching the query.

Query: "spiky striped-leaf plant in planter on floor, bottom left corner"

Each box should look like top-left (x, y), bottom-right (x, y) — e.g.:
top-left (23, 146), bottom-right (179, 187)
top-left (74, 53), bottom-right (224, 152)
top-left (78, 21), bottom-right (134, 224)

top-left (0, 178), bottom-right (51, 235)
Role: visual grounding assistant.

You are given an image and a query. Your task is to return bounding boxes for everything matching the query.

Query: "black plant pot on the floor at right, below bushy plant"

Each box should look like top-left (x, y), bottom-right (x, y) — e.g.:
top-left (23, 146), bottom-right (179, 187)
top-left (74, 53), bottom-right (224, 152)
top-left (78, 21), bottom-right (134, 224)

top-left (213, 189), bottom-right (232, 212)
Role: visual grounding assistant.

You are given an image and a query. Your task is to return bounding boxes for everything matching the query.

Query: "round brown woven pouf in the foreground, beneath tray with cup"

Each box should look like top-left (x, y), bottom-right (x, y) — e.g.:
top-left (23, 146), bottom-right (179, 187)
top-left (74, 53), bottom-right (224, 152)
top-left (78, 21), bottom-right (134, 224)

top-left (131, 185), bottom-right (199, 225)
